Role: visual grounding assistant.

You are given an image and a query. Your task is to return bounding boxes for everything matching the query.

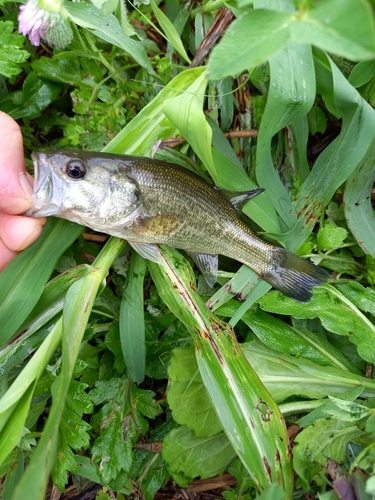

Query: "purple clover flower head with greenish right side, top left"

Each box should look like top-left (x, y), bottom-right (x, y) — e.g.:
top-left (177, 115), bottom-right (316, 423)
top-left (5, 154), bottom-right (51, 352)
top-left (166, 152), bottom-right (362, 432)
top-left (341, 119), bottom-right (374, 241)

top-left (18, 0), bottom-right (73, 49)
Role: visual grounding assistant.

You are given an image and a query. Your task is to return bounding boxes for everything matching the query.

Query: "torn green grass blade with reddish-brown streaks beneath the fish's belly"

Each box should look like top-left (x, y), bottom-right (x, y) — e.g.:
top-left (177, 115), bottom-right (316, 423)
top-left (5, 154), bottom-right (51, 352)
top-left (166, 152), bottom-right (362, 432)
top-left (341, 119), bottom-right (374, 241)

top-left (149, 247), bottom-right (293, 498)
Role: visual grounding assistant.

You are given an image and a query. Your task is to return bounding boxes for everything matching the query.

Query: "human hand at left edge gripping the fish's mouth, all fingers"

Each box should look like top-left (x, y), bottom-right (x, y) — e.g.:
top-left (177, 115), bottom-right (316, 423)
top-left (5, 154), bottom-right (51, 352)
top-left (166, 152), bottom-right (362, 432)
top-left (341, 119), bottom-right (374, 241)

top-left (0, 111), bottom-right (46, 272)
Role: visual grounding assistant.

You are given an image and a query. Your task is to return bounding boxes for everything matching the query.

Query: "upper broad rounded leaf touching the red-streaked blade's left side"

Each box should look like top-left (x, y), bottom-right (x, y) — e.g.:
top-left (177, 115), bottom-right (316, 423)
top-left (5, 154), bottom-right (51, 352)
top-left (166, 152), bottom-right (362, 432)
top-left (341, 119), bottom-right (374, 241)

top-left (167, 348), bottom-right (223, 438)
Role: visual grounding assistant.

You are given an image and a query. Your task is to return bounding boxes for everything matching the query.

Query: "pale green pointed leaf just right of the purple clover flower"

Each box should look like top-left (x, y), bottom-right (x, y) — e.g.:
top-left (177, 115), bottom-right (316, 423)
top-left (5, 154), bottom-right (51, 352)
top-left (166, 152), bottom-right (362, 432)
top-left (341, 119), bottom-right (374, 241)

top-left (64, 2), bottom-right (155, 74)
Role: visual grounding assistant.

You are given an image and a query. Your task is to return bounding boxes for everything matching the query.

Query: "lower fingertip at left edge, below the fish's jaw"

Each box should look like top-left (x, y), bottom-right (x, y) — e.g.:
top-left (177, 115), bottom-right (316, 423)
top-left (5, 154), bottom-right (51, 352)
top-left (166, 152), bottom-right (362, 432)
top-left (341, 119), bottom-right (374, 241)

top-left (0, 214), bottom-right (46, 252)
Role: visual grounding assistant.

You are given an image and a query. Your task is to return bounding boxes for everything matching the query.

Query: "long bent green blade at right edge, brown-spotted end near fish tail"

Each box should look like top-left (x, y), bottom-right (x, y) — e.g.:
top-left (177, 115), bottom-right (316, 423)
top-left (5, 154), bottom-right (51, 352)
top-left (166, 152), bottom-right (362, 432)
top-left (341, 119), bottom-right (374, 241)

top-left (286, 51), bottom-right (375, 251)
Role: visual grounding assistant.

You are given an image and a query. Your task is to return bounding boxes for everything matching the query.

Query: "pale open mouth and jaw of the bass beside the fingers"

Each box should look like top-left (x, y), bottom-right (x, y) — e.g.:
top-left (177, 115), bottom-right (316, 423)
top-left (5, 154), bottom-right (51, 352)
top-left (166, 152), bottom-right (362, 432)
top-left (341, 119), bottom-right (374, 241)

top-left (23, 151), bottom-right (60, 217)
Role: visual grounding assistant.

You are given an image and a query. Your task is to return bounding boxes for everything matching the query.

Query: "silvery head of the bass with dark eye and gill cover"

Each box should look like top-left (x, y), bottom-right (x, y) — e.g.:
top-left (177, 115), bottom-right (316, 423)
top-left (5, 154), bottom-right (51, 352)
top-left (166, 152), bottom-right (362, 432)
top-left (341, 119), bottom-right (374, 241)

top-left (25, 150), bottom-right (138, 229)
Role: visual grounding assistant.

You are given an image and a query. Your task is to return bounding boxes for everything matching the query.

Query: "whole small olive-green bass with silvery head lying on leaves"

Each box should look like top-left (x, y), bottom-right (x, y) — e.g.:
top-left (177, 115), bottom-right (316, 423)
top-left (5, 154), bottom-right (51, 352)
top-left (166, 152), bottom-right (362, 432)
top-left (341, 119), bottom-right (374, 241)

top-left (25, 150), bottom-right (329, 302)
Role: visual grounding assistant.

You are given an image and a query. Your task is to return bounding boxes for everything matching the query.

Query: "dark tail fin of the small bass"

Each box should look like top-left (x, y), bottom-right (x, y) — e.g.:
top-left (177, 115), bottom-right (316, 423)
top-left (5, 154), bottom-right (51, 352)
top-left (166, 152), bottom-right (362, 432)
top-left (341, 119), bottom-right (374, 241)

top-left (262, 247), bottom-right (329, 302)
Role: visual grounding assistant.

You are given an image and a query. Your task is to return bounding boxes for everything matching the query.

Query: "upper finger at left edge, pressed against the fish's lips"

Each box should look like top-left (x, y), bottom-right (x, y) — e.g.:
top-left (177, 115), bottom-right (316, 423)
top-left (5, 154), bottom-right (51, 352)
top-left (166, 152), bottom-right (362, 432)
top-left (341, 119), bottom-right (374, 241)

top-left (0, 111), bottom-right (32, 214)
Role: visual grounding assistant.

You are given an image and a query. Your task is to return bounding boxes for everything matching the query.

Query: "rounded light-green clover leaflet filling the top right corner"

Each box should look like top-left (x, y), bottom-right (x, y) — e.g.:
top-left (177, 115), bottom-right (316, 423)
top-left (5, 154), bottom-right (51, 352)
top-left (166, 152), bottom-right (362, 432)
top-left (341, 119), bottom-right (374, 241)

top-left (290, 0), bottom-right (375, 61)
